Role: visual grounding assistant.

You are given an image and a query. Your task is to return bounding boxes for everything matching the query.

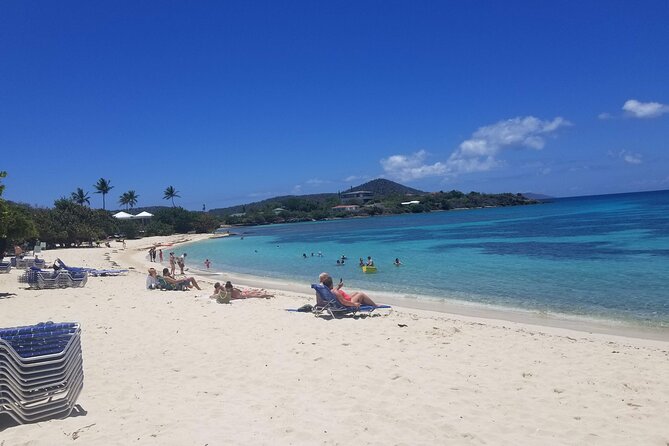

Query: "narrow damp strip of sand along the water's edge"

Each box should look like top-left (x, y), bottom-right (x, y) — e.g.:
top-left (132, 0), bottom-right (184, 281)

top-left (127, 234), bottom-right (669, 342)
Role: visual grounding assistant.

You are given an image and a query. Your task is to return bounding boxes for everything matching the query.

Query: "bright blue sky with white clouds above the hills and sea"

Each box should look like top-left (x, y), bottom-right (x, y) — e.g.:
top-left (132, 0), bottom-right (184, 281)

top-left (0, 0), bottom-right (669, 209)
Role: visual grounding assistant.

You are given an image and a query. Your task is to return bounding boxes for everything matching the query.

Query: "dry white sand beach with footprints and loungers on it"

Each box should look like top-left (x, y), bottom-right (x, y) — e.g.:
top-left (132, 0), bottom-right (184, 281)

top-left (0, 236), bottom-right (669, 446)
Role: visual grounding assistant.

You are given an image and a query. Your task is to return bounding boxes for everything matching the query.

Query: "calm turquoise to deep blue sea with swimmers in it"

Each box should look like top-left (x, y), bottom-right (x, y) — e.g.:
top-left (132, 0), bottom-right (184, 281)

top-left (183, 191), bottom-right (669, 327)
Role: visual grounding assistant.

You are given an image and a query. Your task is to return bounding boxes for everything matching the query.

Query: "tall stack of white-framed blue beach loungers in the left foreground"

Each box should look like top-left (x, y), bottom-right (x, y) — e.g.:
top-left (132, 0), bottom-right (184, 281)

top-left (0, 322), bottom-right (84, 424)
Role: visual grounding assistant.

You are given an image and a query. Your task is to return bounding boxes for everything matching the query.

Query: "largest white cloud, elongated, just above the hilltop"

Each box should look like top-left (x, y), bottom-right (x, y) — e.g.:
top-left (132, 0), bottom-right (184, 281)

top-left (381, 116), bottom-right (571, 181)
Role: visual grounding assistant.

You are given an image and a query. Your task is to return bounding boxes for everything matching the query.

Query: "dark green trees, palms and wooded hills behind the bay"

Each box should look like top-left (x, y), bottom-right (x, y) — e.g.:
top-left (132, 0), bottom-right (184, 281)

top-left (0, 172), bottom-right (537, 253)
